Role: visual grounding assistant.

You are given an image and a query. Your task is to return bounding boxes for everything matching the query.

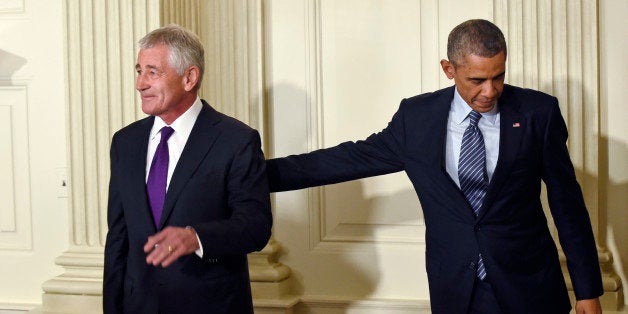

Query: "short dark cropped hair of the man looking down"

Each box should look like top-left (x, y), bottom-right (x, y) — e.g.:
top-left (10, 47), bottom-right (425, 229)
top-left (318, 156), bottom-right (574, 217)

top-left (447, 19), bottom-right (507, 65)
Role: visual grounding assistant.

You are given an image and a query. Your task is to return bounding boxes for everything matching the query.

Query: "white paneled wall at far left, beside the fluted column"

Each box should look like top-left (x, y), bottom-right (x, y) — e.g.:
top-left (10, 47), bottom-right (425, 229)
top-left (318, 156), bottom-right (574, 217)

top-left (0, 0), bottom-right (68, 309)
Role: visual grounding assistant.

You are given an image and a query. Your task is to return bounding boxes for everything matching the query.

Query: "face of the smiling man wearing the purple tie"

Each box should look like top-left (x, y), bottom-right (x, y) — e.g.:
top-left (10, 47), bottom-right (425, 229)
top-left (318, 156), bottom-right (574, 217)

top-left (135, 44), bottom-right (189, 124)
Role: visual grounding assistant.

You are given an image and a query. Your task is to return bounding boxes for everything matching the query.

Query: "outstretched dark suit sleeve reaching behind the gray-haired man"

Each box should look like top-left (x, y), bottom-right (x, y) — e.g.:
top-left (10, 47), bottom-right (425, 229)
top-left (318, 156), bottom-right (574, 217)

top-left (268, 99), bottom-right (406, 192)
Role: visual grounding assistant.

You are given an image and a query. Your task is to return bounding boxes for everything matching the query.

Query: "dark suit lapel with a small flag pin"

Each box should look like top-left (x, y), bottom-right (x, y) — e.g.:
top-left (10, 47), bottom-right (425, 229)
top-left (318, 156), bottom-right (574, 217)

top-left (478, 85), bottom-right (526, 219)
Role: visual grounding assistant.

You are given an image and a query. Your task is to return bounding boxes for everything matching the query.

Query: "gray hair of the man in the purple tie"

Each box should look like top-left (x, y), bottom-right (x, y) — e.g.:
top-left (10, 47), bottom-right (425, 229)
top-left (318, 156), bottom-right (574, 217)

top-left (138, 24), bottom-right (205, 89)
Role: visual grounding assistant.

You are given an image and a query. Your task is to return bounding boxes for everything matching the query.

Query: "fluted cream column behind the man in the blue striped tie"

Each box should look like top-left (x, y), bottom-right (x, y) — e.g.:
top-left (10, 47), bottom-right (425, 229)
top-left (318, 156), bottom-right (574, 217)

top-left (494, 0), bottom-right (623, 310)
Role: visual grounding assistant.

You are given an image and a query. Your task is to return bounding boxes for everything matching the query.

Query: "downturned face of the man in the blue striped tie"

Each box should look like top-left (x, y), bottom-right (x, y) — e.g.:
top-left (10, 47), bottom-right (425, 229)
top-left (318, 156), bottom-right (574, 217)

top-left (441, 51), bottom-right (506, 112)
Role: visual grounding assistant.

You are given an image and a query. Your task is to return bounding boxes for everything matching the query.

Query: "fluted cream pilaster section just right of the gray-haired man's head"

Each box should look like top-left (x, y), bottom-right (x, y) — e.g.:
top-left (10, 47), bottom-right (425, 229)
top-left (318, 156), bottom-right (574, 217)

top-left (197, 0), bottom-right (266, 134)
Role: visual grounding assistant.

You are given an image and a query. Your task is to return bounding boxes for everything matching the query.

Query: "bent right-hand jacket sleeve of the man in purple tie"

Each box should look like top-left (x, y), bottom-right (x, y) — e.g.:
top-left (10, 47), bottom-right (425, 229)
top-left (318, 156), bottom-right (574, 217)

top-left (193, 130), bottom-right (272, 259)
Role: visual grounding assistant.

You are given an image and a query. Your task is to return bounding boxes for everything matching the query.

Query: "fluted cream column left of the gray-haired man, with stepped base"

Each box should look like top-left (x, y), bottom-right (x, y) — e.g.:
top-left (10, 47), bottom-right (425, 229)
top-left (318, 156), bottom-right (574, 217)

top-left (42, 0), bottom-right (159, 313)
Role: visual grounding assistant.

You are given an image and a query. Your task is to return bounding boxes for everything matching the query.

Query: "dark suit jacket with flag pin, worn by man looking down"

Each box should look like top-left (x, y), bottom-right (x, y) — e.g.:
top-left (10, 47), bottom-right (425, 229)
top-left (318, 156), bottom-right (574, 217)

top-left (267, 85), bottom-right (603, 313)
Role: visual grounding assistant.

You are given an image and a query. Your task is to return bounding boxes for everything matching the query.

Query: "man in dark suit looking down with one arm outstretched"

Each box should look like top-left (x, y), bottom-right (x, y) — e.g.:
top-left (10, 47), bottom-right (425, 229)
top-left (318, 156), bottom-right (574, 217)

top-left (267, 20), bottom-right (603, 314)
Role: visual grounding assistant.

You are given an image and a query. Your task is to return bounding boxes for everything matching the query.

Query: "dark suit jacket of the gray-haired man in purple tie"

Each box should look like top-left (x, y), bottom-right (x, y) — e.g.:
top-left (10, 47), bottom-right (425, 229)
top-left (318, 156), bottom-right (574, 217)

top-left (103, 101), bottom-right (272, 314)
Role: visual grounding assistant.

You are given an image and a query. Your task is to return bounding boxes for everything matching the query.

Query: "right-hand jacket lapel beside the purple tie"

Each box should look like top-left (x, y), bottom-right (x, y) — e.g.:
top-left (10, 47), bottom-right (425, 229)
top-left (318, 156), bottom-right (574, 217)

top-left (158, 101), bottom-right (221, 230)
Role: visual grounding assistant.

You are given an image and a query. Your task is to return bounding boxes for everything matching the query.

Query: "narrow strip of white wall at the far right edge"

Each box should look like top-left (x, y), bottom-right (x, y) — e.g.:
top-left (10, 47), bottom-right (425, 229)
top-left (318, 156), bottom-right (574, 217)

top-left (599, 0), bottom-right (628, 303)
